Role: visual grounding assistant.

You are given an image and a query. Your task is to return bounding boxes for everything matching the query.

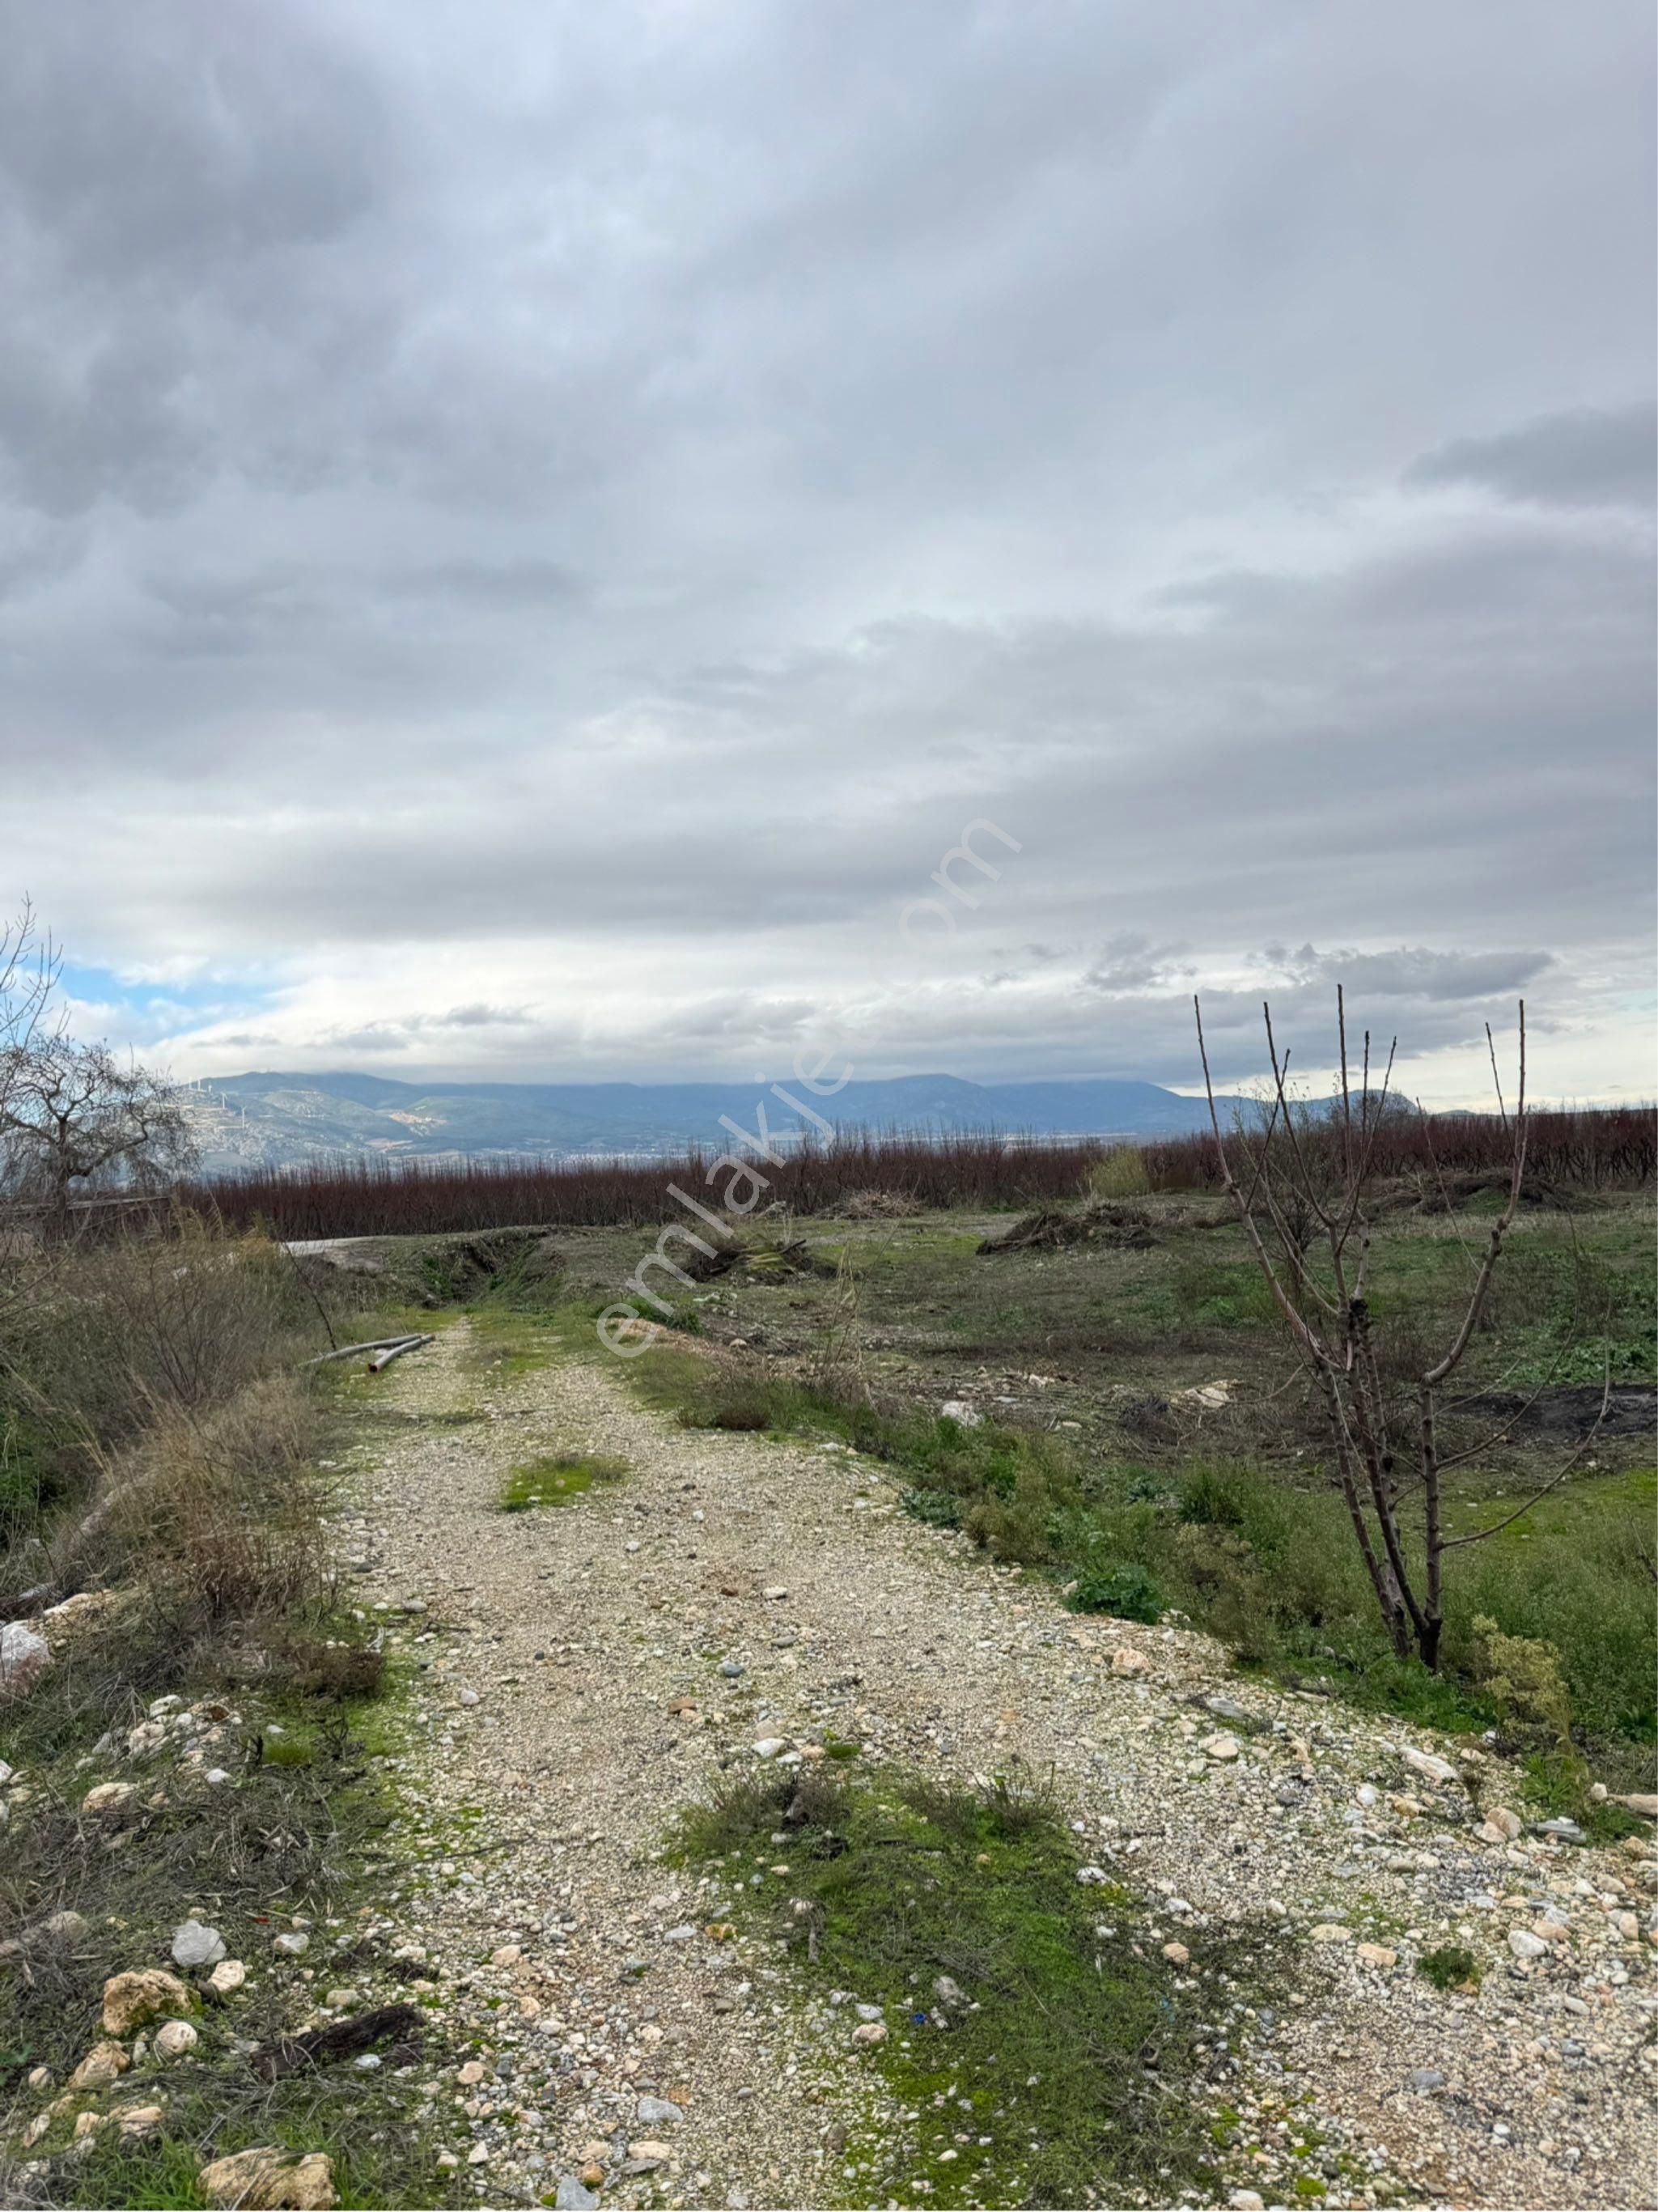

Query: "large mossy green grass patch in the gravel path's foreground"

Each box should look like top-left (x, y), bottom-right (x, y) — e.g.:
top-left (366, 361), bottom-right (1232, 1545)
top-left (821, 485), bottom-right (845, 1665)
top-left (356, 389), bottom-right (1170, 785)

top-left (679, 1769), bottom-right (1265, 2206)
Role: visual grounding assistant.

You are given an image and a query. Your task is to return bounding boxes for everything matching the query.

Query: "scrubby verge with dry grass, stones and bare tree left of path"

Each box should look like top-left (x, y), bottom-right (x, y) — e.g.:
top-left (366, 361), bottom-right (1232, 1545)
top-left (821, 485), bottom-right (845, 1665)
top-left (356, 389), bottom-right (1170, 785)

top-left (0, 906), bottom-right (461, 2206)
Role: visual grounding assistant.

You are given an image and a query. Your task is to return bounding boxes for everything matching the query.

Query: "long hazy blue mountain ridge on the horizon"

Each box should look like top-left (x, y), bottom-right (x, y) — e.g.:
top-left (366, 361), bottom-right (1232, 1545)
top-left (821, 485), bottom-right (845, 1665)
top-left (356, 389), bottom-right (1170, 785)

top-left (185, 1073), bottom-right (1232, 1174)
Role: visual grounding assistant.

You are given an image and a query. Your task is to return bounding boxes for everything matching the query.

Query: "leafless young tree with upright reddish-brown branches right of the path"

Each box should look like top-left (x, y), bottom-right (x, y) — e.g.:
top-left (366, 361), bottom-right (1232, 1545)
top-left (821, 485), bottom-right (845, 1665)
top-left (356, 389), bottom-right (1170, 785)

top-left (1192, 984), bottom-right (1609, 1668)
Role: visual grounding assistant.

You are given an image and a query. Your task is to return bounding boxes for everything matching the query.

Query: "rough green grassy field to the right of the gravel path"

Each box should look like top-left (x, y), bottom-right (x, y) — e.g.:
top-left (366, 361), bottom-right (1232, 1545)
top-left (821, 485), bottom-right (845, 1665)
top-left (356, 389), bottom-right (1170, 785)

top-left (477, 1195), bottom-right (1658, 1827)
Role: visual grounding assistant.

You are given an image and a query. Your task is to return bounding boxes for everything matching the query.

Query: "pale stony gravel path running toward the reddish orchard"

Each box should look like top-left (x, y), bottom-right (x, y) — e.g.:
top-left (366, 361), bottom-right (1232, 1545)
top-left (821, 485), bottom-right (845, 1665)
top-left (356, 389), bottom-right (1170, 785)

top-left (345, 1325), bottom-right (1658, 2206)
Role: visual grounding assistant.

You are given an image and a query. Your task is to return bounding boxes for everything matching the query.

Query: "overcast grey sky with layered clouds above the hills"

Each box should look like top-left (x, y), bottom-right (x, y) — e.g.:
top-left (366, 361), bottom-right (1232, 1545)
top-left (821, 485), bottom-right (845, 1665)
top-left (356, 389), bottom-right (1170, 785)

top-left (0, 0), bottom-right (1658, 1102)
